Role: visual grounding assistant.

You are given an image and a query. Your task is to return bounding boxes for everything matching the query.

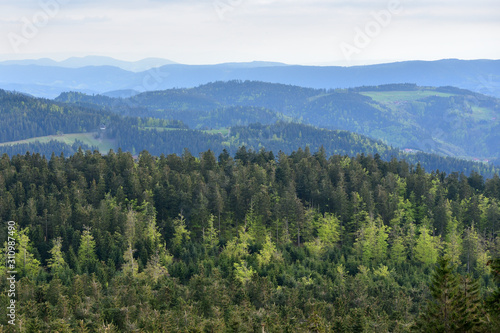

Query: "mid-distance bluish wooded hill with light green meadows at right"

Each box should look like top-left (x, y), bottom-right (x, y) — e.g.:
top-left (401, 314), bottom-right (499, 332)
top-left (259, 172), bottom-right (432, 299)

top-left (57, 81), bottom-right (500, 160)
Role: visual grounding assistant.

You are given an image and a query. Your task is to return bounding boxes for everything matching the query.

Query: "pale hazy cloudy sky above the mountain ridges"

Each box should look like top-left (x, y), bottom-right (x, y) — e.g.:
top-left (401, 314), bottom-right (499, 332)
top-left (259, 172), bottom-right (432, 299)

top-left (0, 0), bottom-right (500, 65)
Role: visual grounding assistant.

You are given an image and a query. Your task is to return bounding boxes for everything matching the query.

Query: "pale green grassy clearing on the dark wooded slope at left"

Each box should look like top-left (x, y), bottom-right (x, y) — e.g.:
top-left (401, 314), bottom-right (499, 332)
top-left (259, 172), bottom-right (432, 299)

top-left (0, 133), bottom-right (116, 153)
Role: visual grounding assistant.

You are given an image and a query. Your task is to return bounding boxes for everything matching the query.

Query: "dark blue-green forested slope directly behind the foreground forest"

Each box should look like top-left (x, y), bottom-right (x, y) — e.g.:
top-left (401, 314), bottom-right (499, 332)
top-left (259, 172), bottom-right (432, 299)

top-left (0, 87), bottom-right (496, 177)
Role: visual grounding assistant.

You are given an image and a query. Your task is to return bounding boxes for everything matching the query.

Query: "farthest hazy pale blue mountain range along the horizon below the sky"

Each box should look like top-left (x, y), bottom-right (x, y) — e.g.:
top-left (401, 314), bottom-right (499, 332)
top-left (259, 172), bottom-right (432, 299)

top-left (0, 59), bottom-right (500, 98)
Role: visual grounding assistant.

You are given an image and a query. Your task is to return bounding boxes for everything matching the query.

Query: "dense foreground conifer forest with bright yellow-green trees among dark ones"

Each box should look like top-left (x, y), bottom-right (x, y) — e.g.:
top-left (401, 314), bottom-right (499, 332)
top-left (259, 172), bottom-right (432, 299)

top-left (0, 148), bottom-right (500, 332)
